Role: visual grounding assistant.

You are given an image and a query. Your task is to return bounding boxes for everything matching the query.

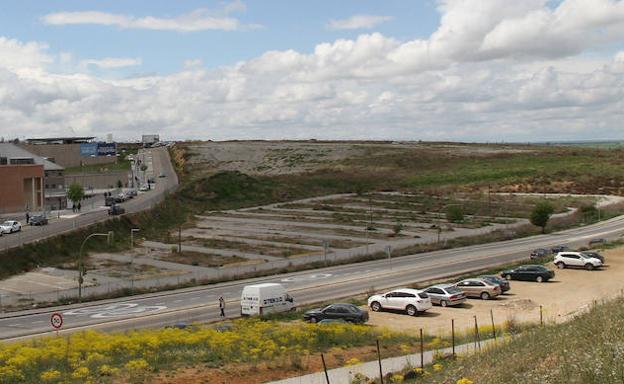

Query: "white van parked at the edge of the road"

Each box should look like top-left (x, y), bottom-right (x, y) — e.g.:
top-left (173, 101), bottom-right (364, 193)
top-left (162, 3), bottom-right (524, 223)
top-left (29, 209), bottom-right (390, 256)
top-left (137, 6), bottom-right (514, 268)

top-left (241, 283), bottom-right (296, 316)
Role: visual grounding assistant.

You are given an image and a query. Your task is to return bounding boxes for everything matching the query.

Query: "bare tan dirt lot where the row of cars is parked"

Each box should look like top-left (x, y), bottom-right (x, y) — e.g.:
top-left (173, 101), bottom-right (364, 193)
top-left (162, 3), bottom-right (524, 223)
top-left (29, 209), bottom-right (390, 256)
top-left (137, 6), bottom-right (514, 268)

top-left (369, 248), bottom-right (624, 335)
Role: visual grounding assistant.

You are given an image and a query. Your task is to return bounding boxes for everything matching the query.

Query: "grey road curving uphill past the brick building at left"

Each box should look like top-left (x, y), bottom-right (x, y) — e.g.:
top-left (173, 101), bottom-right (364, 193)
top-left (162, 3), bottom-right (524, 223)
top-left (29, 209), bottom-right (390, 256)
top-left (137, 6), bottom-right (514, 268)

top-left (0, 148), bottom-right (178, 250)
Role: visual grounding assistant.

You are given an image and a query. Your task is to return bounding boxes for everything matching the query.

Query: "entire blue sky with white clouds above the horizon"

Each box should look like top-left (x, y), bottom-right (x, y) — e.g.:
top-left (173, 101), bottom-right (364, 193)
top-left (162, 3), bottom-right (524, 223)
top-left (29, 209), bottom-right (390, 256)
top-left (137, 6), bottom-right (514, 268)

top-left (0, 0), bottom-right (624, 141)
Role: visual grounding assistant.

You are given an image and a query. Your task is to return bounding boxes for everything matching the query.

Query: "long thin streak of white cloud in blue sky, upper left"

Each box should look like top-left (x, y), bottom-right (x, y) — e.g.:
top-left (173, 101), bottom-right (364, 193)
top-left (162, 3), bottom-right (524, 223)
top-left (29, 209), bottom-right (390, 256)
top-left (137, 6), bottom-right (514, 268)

top-left (42, 1), bottom-right (261, 32)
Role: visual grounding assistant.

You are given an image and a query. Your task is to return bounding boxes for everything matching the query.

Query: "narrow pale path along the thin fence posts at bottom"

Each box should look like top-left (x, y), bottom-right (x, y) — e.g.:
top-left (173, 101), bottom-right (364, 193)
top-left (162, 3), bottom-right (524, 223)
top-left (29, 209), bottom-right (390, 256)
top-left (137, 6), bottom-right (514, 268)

top-left (269, 339), bottom-right (494, 384)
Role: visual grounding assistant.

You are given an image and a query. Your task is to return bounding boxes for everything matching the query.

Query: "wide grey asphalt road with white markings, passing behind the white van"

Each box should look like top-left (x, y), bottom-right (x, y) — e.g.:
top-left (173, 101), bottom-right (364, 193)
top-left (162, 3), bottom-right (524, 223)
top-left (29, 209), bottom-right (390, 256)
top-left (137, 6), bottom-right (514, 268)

top-left (0, 216), bottom-right (624, 340)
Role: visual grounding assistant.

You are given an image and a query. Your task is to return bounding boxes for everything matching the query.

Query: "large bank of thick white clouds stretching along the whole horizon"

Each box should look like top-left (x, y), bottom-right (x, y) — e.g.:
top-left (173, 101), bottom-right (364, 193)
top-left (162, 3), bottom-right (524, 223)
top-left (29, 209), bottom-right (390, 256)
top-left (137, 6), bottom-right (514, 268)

top-left (0, 0), bottom-right (624, 141)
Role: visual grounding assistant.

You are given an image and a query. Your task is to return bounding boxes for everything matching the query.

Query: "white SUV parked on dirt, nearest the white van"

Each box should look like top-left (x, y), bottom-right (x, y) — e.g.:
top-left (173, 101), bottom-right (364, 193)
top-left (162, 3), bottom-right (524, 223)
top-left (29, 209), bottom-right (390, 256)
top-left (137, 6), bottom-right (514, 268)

top-left (368, 288), bottom-right (431, 316)
